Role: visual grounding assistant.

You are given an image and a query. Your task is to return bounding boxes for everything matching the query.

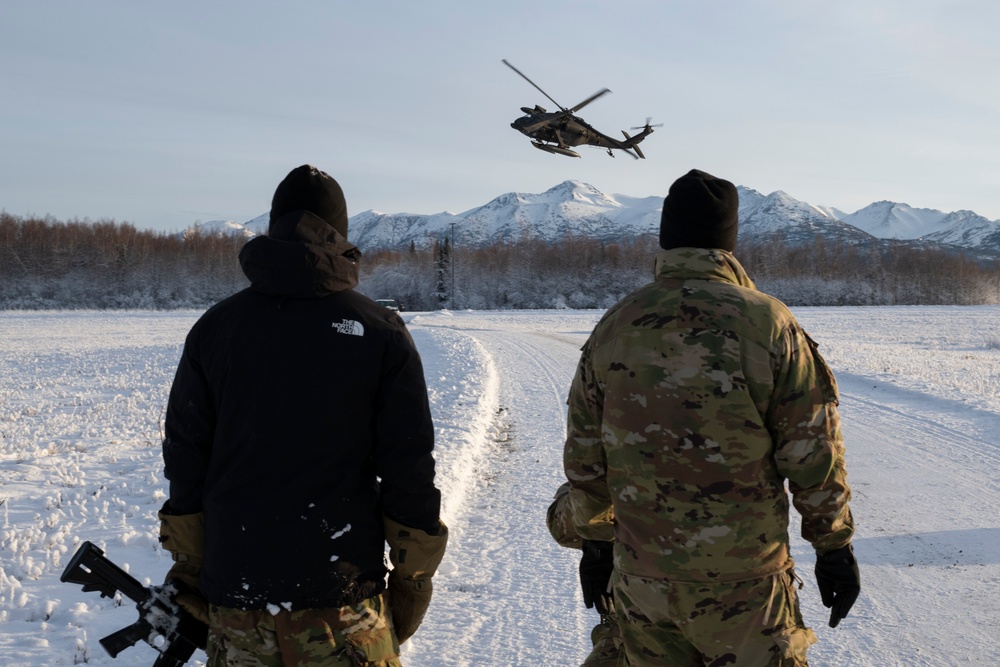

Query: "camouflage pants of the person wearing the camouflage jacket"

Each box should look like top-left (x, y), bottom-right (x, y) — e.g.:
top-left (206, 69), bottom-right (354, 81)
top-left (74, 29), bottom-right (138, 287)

top-left (612, 570), bottom-right (816, 667)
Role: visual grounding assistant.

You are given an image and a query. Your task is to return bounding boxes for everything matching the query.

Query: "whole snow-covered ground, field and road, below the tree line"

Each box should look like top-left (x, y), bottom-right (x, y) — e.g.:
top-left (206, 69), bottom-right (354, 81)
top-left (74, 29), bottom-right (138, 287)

top-left (0, 307), bottom-right (1000, 667)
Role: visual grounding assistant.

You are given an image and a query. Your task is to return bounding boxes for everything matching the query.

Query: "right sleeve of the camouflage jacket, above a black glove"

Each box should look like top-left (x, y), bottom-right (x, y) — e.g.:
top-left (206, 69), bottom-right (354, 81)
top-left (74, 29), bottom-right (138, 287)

top-left (768, 320), bottom-right (854, 553)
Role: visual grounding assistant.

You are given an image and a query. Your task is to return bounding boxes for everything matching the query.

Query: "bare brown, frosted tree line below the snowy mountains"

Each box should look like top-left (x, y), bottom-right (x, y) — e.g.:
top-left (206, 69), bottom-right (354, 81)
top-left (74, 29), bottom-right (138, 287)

top-left (0, 213), bottom-right (1000, 310)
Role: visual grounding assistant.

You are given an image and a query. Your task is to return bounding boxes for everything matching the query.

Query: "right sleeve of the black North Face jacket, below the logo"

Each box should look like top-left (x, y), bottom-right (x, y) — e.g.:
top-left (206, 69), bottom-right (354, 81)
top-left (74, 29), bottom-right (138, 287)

top-left (375, 320), bottom-right (441, 535)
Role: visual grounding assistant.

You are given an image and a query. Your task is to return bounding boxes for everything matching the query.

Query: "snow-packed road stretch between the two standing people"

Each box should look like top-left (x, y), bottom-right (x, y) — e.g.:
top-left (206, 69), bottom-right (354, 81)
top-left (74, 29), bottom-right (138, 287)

top-left (403, 321), bottom-right (597, 667)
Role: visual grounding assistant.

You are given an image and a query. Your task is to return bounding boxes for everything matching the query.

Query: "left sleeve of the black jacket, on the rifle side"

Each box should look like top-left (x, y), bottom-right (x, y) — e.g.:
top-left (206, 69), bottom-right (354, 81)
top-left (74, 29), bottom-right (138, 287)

top-left (163, 324), bottom-right (215, 514)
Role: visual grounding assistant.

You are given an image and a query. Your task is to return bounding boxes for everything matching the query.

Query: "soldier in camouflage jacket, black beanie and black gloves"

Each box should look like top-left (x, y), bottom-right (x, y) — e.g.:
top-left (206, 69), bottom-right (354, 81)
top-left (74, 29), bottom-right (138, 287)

top-left (564, 170), bottom-right (858, 665)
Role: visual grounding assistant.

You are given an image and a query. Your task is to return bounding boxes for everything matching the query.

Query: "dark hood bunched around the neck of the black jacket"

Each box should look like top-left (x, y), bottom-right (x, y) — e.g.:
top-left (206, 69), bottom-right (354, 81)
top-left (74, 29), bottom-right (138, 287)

top-left (240, 211), bottom-right (361, 298)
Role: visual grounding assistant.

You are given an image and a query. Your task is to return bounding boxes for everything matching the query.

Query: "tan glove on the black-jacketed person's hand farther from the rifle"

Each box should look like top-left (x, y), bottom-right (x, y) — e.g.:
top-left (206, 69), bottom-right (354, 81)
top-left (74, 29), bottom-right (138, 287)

top-left (383, 517), bottom-right (448, 644)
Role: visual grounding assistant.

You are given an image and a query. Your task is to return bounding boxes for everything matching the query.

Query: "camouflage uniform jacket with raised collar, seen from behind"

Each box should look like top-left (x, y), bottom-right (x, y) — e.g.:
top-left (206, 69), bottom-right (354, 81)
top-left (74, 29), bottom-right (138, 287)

top-left (564, 248), bottom-right (854, 582)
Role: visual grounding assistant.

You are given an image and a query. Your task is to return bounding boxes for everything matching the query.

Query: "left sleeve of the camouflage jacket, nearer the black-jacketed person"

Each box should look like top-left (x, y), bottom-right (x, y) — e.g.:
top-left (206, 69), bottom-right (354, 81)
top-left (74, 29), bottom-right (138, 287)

top-left (563, 330), bottom-right (614, 541)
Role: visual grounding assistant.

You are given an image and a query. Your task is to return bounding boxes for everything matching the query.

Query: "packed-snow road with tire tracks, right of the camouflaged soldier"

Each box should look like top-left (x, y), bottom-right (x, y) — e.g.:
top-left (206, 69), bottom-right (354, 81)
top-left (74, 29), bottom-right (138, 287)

top-left (793, 373), bottom-right (1000, 667)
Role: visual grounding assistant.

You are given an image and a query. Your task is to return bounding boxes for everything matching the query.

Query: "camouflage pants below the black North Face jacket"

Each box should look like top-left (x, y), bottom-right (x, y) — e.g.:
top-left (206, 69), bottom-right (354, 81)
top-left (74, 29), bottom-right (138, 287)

top-left (207, 595), bottom-right (401, 667)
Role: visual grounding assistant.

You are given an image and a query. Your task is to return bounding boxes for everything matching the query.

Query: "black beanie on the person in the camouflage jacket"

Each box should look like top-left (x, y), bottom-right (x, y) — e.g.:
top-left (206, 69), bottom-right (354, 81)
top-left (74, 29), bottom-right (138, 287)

top-left (660, 169), bottom-right (740, 252)
